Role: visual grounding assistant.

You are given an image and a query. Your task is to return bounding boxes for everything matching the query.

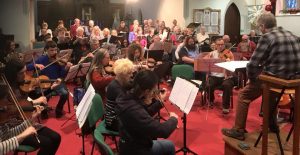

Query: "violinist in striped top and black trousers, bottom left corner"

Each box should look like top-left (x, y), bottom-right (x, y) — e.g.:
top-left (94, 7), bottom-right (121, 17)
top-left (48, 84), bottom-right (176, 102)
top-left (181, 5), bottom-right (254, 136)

top-left (0, 84), bottom-right (61, 155)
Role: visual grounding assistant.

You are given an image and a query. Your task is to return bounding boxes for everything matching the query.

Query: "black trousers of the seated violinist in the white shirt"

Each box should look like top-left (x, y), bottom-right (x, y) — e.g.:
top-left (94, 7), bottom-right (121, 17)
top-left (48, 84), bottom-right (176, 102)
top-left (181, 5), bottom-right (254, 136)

top-left (206, 76), bottom-right (237, 109)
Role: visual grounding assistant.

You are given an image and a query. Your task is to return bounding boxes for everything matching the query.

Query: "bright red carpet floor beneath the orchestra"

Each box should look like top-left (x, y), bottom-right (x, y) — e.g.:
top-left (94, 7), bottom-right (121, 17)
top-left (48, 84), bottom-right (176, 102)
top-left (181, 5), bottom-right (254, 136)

top-left (24, 84), bottom-right (292, 155)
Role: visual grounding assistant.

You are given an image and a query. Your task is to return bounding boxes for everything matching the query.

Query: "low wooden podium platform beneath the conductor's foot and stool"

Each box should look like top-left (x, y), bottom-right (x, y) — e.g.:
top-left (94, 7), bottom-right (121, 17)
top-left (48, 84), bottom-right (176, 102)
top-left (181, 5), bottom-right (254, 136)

top-left (223, 132), bottom-right (293, 155)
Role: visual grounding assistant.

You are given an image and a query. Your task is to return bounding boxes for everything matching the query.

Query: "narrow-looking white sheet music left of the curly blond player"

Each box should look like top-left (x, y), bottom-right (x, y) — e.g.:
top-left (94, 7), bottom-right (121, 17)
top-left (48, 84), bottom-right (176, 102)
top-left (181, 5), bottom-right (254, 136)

top-left (76, 85), bottom-right (95, 128)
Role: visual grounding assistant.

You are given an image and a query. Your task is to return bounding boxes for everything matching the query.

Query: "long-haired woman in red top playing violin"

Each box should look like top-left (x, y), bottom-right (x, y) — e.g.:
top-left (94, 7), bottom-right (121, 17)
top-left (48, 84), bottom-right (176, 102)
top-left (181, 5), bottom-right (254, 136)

top-left (88, 48), bottom-right (114, 101)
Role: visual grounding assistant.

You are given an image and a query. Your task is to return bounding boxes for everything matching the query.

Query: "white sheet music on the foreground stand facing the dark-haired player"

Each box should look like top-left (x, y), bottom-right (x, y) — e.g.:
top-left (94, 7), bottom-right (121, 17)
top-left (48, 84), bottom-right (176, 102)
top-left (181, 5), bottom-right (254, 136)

top-left (169, 77), bottom-right (198, 114)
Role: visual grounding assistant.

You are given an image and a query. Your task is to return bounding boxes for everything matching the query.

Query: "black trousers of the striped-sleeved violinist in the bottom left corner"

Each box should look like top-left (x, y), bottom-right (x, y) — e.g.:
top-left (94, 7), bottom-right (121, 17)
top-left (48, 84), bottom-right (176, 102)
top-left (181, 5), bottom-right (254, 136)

top-left (21, 127), bottom-right (61, 155)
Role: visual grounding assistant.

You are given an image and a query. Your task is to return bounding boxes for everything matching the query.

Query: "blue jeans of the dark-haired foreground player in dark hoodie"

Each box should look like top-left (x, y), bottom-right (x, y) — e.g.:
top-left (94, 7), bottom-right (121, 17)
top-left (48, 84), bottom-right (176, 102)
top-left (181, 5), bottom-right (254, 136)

top-left (152, 140), bottom-right (175, 155)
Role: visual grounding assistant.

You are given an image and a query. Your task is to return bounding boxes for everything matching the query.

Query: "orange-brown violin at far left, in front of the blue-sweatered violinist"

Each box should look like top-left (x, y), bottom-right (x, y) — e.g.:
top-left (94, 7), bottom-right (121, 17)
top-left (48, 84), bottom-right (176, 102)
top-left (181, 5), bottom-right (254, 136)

top-left (20, 74), bottom-right (57, 93)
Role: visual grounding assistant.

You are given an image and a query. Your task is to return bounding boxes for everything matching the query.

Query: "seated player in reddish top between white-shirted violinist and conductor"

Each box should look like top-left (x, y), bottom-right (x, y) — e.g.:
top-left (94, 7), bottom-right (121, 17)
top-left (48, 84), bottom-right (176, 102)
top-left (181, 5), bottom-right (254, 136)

top-left (237, 35), bottom-right (256, 60)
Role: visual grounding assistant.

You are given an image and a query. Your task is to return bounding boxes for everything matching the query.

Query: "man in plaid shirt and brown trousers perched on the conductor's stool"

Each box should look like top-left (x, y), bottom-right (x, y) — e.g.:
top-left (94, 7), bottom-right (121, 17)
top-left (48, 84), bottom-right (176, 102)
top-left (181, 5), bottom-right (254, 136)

top-left (222, 13), bottom-right (300, 140)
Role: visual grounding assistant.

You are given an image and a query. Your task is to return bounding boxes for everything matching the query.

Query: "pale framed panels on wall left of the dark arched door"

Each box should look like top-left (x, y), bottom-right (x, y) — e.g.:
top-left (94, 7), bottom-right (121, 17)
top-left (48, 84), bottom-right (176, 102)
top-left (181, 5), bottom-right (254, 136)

top-left (193, 8), bottom-right (221, 34)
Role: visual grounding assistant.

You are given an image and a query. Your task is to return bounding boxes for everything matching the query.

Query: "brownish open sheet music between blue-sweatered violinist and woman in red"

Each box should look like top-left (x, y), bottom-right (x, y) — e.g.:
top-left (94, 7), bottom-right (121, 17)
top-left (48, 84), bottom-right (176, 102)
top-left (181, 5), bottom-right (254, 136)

top-left (65, 63), bottom-right (91, 81)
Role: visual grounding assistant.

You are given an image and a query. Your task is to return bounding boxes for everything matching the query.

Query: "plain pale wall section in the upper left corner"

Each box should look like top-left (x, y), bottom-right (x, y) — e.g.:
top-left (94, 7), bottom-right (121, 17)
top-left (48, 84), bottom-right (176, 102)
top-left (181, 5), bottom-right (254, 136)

top-left (0, 0), bottom-right (34, 50)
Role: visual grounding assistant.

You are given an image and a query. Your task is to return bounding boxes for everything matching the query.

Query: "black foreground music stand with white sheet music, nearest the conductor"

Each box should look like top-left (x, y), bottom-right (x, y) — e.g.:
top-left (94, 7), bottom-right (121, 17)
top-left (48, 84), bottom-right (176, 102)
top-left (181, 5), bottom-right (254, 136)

top-left (169, 77), bottom-right (199, 155)
